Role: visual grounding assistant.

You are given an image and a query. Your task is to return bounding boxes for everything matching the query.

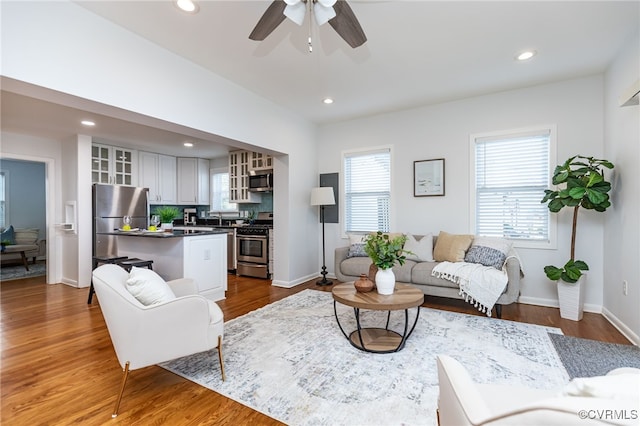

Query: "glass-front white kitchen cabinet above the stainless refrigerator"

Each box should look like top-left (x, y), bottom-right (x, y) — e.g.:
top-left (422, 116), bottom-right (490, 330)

top-left (91, 144), bottom-right (138, 186)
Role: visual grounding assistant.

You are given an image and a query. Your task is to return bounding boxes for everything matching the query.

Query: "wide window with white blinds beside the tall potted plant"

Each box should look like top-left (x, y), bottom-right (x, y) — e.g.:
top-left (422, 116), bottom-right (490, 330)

top-left (470, 126), bottom-right (555, 248)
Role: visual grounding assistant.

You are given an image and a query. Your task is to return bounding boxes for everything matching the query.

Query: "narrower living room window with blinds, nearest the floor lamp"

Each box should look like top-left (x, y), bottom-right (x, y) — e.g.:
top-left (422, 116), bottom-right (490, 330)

top-left (343, 148), bottom-right (391, 232)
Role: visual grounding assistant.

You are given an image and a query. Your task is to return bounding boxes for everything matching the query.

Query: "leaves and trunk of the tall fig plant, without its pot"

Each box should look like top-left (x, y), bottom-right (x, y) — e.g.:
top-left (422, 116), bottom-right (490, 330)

top-left (541, 155), bottom-right (614, 283)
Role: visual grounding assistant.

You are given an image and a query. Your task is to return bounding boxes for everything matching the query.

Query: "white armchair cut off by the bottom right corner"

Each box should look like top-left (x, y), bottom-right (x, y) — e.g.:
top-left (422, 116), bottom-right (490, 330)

top-left (437, 355), bottom-right (640, 426)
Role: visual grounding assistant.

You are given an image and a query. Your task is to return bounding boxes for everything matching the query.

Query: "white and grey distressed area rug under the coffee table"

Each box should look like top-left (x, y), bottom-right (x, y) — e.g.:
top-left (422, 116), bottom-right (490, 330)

top-left (161, 290), bottom-right (568, 425)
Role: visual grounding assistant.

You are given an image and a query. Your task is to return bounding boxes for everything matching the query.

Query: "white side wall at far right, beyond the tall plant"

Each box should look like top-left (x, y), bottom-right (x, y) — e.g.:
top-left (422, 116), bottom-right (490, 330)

top-left (604, 30), bottom-right (640, 344)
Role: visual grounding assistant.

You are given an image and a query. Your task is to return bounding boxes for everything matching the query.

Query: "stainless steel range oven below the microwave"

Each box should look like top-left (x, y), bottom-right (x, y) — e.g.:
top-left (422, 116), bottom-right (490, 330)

top-left (236, 212), bottom-right (273, 278)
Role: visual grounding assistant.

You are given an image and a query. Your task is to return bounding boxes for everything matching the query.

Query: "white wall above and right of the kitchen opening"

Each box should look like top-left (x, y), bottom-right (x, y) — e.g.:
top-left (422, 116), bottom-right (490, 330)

top-left (2, 1), bottom-right (319, 285)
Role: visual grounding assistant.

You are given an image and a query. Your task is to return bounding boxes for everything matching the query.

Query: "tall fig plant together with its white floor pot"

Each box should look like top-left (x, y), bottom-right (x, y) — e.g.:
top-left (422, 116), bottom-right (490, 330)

top-left (541, 155), bottom-right (614, 321)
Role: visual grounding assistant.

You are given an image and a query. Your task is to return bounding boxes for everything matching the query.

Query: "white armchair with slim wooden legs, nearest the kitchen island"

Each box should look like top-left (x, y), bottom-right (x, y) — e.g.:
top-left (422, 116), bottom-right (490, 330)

top-left (93, 264), bottom-right (225, 417)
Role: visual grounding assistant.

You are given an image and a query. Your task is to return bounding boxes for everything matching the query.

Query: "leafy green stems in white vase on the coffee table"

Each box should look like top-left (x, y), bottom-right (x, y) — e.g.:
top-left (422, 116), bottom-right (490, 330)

top-left (364, 231), bottom-right (410, 296)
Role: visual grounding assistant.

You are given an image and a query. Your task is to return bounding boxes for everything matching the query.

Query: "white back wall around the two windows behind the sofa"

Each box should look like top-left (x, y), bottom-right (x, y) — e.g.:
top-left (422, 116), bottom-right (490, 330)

top-left (317, 75), bottom-right (604, 311)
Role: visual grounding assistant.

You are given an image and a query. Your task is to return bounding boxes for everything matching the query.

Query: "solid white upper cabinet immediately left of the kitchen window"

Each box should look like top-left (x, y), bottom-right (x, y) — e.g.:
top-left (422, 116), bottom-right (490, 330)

top-left (178, 157), bottom-right (209, 205)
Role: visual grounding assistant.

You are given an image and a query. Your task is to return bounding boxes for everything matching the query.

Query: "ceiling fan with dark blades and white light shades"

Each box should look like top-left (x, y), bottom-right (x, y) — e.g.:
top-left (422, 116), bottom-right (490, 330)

top-left (249, 0), bottom-right (367, 51)
